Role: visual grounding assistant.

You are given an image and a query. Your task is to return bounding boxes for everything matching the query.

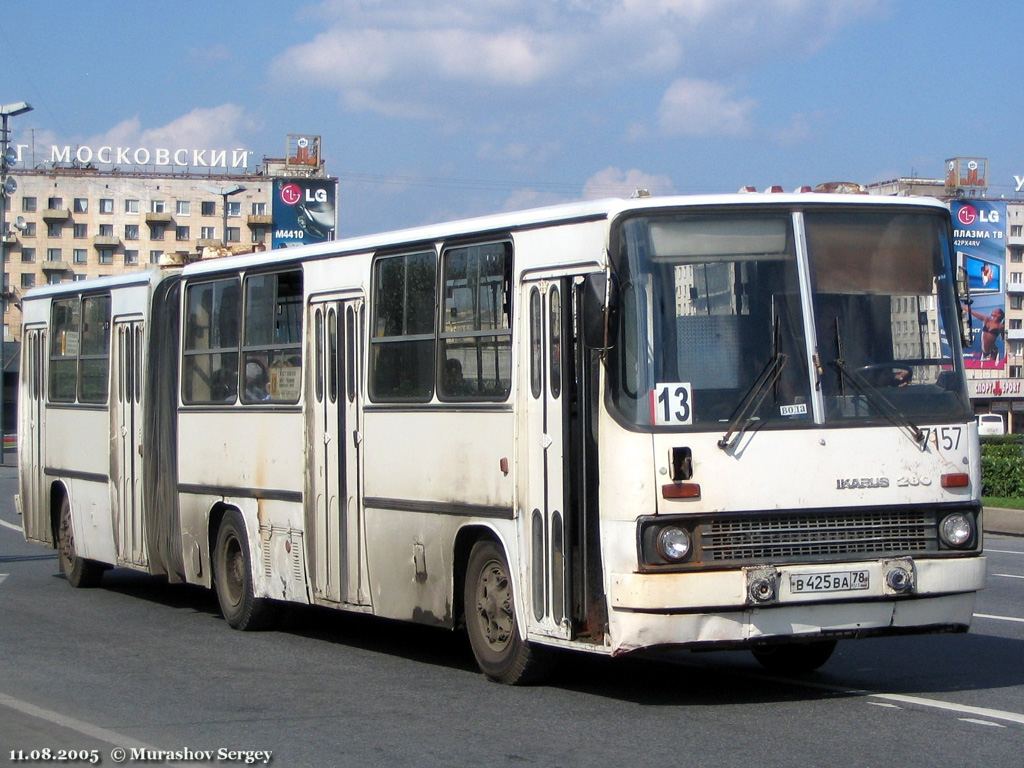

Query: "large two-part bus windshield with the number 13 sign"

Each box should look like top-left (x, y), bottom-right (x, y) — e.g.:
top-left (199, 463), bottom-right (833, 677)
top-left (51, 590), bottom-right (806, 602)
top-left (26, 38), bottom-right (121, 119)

top-left (608, 207), bottom-right (970, 429)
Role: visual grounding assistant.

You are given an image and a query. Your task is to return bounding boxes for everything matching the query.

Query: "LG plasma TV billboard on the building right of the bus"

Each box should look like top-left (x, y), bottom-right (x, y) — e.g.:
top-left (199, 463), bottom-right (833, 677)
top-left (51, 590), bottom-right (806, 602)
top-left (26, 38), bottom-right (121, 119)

top-left (949, 200), bottom-right (1007, 371)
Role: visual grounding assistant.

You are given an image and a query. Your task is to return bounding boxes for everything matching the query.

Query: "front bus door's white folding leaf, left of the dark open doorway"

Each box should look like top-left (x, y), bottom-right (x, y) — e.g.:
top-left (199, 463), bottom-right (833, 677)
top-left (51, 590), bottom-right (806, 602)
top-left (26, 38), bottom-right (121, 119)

top-left (519, 279), bottom-right (573, 637)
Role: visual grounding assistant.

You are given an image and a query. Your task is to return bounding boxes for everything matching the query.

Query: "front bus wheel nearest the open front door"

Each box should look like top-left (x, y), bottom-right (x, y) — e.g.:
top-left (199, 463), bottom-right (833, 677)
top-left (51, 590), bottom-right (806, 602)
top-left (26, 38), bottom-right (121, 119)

top-left (463, 540), bottom-right (550, 685)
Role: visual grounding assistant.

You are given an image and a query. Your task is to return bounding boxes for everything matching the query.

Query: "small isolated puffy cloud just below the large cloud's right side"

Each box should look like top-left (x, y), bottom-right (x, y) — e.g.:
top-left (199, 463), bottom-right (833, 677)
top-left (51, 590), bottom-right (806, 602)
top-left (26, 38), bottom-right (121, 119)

top-left (658, 78), bottom-right (756, 136)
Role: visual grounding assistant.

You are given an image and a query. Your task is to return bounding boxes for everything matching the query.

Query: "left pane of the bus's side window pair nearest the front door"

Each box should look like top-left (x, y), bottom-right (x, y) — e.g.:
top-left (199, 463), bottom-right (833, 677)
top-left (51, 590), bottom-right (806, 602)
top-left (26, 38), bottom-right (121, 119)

top-left (370, 250), bottom-right (437, 402)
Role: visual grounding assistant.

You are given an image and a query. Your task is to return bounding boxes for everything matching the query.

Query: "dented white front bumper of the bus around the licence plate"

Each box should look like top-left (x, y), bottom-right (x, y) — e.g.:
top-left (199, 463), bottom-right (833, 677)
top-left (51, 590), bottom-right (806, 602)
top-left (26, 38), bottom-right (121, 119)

top-left (608, 557), bottom-right (985, 653)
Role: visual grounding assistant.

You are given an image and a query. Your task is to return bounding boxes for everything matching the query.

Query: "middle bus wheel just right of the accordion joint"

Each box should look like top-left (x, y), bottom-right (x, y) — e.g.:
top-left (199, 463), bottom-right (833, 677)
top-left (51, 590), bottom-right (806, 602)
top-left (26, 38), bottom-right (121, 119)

top-left (212, 510), bottom-right (274, 631)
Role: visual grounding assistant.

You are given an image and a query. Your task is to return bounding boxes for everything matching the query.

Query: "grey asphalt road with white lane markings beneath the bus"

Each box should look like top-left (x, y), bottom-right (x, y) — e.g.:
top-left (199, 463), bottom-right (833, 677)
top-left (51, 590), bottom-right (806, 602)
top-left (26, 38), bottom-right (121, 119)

top-left (0, 468), bottom-right (1024, 768)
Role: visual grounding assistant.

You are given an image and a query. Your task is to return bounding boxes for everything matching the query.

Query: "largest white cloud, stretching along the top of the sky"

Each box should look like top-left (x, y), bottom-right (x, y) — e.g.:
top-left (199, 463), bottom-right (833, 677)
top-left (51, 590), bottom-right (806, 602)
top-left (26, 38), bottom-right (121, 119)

top-left (270, 0), bottom-right (885, 123)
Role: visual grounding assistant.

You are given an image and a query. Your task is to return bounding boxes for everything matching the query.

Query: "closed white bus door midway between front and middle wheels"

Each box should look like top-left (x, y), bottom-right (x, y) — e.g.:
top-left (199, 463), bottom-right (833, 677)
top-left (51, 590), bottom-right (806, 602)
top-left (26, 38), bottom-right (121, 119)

top-left (308, 298), bottom-right (369, 605)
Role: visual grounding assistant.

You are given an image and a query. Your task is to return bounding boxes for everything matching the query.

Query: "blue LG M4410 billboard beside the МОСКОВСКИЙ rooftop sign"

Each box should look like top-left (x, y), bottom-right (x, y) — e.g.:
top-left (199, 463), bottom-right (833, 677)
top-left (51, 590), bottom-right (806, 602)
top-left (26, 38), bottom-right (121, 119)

top-left (272, 178), bottom-right (338, 248)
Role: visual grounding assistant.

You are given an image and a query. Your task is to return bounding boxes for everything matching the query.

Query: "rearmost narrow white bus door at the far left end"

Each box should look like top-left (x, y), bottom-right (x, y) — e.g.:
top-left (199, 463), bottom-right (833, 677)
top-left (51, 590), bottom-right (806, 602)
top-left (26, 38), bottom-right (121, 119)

top-left (17, 328), bottom-right (53, 544)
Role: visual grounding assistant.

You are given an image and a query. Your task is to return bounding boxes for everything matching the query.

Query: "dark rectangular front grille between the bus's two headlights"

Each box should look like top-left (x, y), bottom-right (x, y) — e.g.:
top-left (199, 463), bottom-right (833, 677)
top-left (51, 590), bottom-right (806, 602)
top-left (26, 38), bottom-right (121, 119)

top-left (699, 509), bottom-right (939, 565)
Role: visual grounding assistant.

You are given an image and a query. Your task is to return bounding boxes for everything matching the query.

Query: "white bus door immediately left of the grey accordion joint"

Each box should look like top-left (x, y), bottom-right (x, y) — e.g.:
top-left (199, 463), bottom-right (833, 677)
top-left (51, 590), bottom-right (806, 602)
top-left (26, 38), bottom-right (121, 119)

top-left (111, 317), bottom-right (147, 566)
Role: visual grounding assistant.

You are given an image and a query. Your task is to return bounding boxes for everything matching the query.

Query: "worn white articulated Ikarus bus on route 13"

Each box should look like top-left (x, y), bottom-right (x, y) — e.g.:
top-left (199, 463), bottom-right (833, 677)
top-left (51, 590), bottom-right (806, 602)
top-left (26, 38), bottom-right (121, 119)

top-left (18, 194), bottom-right (985, 682)
